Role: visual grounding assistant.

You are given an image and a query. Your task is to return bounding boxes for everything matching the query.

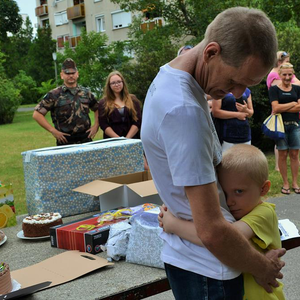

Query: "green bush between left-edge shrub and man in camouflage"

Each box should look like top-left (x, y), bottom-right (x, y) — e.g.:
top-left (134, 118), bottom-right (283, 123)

top-left (13, 70), bottom-right (39, 104)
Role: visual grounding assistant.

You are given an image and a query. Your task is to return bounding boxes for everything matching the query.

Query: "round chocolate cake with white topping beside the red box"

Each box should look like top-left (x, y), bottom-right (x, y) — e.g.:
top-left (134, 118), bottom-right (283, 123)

top-left (22, 213), bottom-right (62, 237)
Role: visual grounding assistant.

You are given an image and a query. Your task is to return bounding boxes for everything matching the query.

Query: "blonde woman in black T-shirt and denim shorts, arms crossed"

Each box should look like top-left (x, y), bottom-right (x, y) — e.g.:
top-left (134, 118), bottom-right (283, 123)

top-left (269, 63), bottom-right (300, 195)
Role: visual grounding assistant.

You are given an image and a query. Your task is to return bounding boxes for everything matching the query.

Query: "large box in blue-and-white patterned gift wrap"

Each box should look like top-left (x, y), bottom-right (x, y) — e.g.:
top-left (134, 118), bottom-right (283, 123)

top-left (22, 138), bottom-right (144, 217)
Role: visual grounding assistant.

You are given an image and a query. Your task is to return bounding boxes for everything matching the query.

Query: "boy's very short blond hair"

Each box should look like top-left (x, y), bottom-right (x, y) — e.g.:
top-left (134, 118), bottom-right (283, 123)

top-left (218, 144), bottom-right (269, 186)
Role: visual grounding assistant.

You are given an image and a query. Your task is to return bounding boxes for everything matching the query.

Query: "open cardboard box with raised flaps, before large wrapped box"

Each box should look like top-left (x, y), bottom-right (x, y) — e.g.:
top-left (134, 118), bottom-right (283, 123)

top-left (74, 171), bottom-right (163, 211)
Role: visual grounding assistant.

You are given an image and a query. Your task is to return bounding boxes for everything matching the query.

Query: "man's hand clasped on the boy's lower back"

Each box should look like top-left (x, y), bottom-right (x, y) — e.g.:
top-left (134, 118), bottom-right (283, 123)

top-left (254, 248), bottom-right (286, 293)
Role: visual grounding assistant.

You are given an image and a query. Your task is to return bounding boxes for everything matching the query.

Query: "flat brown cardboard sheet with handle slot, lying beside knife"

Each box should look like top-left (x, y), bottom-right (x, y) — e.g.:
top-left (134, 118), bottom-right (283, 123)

top-left (0, 251), bottom-right (113, 299)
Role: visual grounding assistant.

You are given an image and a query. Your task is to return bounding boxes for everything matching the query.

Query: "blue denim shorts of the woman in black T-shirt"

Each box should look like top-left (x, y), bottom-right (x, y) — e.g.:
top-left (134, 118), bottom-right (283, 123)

top-left (276, 124), bottom-right (300, 150)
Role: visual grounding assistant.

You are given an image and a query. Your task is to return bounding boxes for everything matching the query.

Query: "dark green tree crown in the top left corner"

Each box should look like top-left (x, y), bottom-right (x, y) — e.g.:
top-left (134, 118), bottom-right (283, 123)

top-left (0, 0), bottom-right (22, 41)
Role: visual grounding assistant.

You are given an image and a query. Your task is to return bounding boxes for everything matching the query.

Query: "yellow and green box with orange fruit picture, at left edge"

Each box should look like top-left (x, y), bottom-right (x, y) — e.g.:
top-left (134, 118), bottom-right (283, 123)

top-left (0, 184), bottom-right (17, 228)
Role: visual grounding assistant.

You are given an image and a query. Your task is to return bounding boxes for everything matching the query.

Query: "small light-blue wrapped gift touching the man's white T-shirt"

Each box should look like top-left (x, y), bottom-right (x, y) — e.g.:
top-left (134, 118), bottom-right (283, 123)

top-left (126, 209), bottom-right (164, 269)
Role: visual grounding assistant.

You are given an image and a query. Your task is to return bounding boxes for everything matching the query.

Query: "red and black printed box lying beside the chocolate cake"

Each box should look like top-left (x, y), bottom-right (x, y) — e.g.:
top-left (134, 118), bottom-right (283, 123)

top-left (50, 214), bottom-right (124, 254)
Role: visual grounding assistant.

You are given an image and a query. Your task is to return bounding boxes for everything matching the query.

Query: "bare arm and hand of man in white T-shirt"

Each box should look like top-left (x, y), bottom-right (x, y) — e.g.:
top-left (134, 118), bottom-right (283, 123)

top-left (185, 183), bottom-right (285, 292)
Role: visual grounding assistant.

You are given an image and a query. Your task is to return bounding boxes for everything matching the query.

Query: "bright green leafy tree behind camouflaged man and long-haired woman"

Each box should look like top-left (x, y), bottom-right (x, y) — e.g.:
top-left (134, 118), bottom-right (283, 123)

top-left (58, 29), bottom-right (129, 97)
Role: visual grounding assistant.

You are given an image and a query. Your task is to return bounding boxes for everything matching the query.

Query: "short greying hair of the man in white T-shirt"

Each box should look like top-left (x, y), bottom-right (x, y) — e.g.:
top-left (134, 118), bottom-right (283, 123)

top-left (204, 7), bottom-right (278, 69)
